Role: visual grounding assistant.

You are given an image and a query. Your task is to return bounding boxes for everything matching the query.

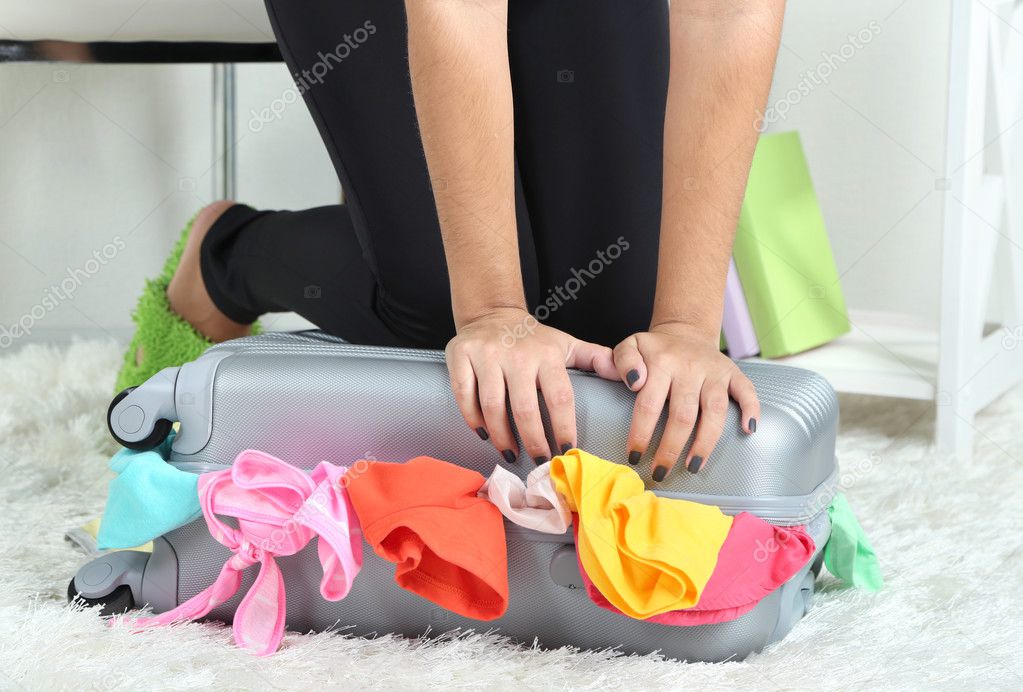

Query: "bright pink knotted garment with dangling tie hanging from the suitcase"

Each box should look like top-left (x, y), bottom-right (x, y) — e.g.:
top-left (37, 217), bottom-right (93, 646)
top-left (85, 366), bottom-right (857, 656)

top-left (125, 449), bottom-right (362, 656)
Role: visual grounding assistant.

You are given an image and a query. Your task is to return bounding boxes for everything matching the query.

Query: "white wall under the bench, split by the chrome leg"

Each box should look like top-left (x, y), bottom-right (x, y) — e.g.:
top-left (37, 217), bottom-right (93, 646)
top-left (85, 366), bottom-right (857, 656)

top-left (0, 59), bottom-right (340, 344)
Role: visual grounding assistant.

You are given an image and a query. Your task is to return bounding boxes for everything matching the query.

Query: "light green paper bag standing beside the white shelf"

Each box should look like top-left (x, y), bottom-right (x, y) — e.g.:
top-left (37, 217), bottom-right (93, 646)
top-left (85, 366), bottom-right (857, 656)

top-left (732, 132), bottom-right (849, 358)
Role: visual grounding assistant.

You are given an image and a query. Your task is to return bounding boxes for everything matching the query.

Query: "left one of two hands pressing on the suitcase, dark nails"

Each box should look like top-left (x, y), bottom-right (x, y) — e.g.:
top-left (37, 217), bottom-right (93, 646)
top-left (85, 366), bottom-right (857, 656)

top-left (445, 308), bottom-right (618, 465)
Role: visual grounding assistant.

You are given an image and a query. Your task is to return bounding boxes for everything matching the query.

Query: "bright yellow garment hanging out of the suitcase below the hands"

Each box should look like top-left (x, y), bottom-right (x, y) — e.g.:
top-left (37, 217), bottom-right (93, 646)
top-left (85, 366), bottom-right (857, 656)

top-left (550, 449), bottom-right (731, 619)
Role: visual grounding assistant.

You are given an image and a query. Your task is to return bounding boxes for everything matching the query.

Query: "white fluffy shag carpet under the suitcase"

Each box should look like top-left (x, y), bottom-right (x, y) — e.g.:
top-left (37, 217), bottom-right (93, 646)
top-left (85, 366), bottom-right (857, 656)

top-left (0, 342), bottom-right (1023, 690)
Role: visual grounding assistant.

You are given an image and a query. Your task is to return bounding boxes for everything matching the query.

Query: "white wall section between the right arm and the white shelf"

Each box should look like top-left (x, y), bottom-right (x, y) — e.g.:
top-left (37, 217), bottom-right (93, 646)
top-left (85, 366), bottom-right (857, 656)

top-left (768, 0), bottom-right (949, 325)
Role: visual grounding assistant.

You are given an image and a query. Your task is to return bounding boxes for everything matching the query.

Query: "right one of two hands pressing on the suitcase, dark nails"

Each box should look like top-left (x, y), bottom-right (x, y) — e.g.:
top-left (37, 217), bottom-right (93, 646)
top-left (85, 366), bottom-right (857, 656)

top-left (615, 322), bottom-right (760, 482)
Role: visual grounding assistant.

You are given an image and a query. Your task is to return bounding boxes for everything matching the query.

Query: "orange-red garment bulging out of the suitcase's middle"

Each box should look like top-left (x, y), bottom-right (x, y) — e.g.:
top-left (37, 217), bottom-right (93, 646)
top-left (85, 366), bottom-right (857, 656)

top-left (347, 457), bottom-right (508, 620)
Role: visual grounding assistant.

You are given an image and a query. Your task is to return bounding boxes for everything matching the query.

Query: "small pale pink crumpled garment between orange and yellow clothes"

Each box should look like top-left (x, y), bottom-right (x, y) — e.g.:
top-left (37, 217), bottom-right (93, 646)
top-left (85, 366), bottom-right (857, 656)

top-left (479, 462), bottom-right (572, 533)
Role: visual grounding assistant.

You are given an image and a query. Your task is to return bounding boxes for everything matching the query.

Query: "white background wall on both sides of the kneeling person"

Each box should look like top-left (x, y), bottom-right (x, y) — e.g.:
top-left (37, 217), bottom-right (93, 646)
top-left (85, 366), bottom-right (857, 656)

top-left (0, 0), bottom-right (948, 345)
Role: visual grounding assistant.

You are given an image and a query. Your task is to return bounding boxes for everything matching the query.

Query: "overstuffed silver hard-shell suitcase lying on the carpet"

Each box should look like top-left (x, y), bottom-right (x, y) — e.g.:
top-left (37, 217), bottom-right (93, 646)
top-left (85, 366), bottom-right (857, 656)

top-left (69, 332), bottom-right (838, 661)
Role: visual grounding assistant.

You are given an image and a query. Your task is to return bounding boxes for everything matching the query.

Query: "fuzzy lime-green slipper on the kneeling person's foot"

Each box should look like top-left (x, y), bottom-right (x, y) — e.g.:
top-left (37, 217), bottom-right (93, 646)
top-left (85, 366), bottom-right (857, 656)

top-left (115, 217), bottom-right (260, 392)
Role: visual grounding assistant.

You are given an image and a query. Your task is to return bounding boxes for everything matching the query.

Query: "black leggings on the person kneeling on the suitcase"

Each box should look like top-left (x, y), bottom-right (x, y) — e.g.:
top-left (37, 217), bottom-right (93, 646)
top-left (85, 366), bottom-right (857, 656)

top-left (202, 0), bottom-right (668, 348)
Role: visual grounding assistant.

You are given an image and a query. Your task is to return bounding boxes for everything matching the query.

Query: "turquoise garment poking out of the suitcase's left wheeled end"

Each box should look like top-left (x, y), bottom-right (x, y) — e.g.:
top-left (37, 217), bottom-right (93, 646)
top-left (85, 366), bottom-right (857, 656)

top-left (97, 433), bottom-right (203, 550)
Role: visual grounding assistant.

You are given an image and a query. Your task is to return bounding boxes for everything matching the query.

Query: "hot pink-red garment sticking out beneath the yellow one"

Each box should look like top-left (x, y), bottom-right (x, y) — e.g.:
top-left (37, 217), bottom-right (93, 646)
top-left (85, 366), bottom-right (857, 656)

top-left (574, 512), bottom-right (815, 625)
